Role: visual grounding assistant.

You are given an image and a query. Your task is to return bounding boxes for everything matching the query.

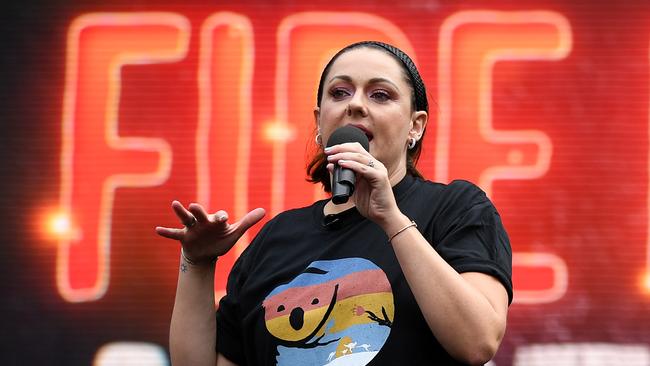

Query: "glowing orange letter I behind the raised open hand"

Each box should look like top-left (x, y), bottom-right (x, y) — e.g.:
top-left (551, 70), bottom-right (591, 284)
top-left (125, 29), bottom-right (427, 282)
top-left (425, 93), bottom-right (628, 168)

top-left (196, 13), bottom-right (255, 298)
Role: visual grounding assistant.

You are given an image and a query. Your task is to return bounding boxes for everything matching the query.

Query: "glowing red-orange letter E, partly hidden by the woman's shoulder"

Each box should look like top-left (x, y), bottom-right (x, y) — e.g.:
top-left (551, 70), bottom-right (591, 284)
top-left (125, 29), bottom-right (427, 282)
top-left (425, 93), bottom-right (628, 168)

top-left (435, 11), bottom-right (571, 303)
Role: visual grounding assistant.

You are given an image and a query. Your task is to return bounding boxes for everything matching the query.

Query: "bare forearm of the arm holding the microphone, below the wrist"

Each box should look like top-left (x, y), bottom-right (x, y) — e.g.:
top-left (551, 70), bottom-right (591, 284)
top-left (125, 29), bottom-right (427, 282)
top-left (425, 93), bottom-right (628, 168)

top-left (384, 215), bottom-right (505, 363)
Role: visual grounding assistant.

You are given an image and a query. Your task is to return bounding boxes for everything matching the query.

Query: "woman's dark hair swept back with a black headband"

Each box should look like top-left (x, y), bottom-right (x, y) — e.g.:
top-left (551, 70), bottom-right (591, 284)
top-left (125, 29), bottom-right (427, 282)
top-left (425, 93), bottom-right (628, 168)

top-left (307, 41), bottom-right (429, 192)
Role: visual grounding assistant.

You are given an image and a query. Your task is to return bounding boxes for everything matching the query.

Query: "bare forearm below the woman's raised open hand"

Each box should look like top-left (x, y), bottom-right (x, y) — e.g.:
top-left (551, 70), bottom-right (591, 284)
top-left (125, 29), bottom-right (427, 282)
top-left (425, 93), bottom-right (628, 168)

top-left (169, 254), bottom-right (216, 366)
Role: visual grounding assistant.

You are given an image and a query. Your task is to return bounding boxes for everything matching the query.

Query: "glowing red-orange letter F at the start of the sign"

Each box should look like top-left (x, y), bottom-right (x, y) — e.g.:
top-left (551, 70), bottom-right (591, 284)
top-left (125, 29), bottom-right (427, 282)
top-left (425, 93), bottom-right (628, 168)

top-left (57, 13), bottom-right (190, 302)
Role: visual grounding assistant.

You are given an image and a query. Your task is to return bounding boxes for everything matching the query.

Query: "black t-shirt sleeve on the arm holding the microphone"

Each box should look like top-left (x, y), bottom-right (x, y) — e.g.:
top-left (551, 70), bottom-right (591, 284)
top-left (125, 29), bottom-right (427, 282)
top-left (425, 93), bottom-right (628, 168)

top-left (433, 180), bottom-right (513, 303)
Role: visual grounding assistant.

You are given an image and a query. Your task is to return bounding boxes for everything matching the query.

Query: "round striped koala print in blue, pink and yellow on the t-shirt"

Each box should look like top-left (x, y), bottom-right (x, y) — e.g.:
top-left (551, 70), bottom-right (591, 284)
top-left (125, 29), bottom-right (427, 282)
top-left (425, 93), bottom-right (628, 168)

top-left (262, 258), bottom-right (395, 365)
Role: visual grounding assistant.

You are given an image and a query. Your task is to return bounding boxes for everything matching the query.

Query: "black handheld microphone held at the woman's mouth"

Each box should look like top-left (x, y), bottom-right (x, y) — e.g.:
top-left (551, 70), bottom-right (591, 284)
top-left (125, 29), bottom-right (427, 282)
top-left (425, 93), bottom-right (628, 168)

top-left (327, 125), bottom-right (370, 205)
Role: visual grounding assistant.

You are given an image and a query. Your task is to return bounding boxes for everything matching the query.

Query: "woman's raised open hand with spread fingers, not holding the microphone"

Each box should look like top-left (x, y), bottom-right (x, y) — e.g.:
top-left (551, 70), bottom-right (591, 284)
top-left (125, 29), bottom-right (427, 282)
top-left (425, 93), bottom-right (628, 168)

top-left (156, 201), bottom-right (265, 264)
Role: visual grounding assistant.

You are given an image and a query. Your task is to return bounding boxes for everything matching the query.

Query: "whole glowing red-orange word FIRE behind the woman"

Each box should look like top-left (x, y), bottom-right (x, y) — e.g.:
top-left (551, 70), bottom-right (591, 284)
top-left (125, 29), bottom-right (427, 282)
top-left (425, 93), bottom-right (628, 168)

top-left (57, 11), bottom-right (571, 302)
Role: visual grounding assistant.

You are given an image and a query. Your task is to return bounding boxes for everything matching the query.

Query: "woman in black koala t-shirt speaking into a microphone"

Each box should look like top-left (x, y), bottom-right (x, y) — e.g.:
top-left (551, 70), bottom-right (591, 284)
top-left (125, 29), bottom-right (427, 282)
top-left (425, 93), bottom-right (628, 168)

top-left (157, 42), bottom-right (512, 366)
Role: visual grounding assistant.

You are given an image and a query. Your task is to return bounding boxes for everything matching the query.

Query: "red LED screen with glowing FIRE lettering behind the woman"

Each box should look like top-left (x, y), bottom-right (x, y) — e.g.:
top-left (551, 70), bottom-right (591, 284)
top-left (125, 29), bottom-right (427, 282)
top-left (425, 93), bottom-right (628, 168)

top-left (0, 1), bottom-right (650, 365)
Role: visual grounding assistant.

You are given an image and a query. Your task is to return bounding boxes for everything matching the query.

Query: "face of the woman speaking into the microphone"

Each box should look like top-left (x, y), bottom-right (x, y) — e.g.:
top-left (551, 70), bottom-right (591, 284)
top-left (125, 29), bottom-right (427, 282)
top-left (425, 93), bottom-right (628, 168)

top-left (315, 48), bottom-right (423, 179)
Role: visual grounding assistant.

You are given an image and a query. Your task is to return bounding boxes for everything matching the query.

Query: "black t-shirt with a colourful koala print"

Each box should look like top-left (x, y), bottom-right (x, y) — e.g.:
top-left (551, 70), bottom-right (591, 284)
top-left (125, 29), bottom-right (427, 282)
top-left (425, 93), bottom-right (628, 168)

top-left (217, 175), bottom-right (512, 366)
